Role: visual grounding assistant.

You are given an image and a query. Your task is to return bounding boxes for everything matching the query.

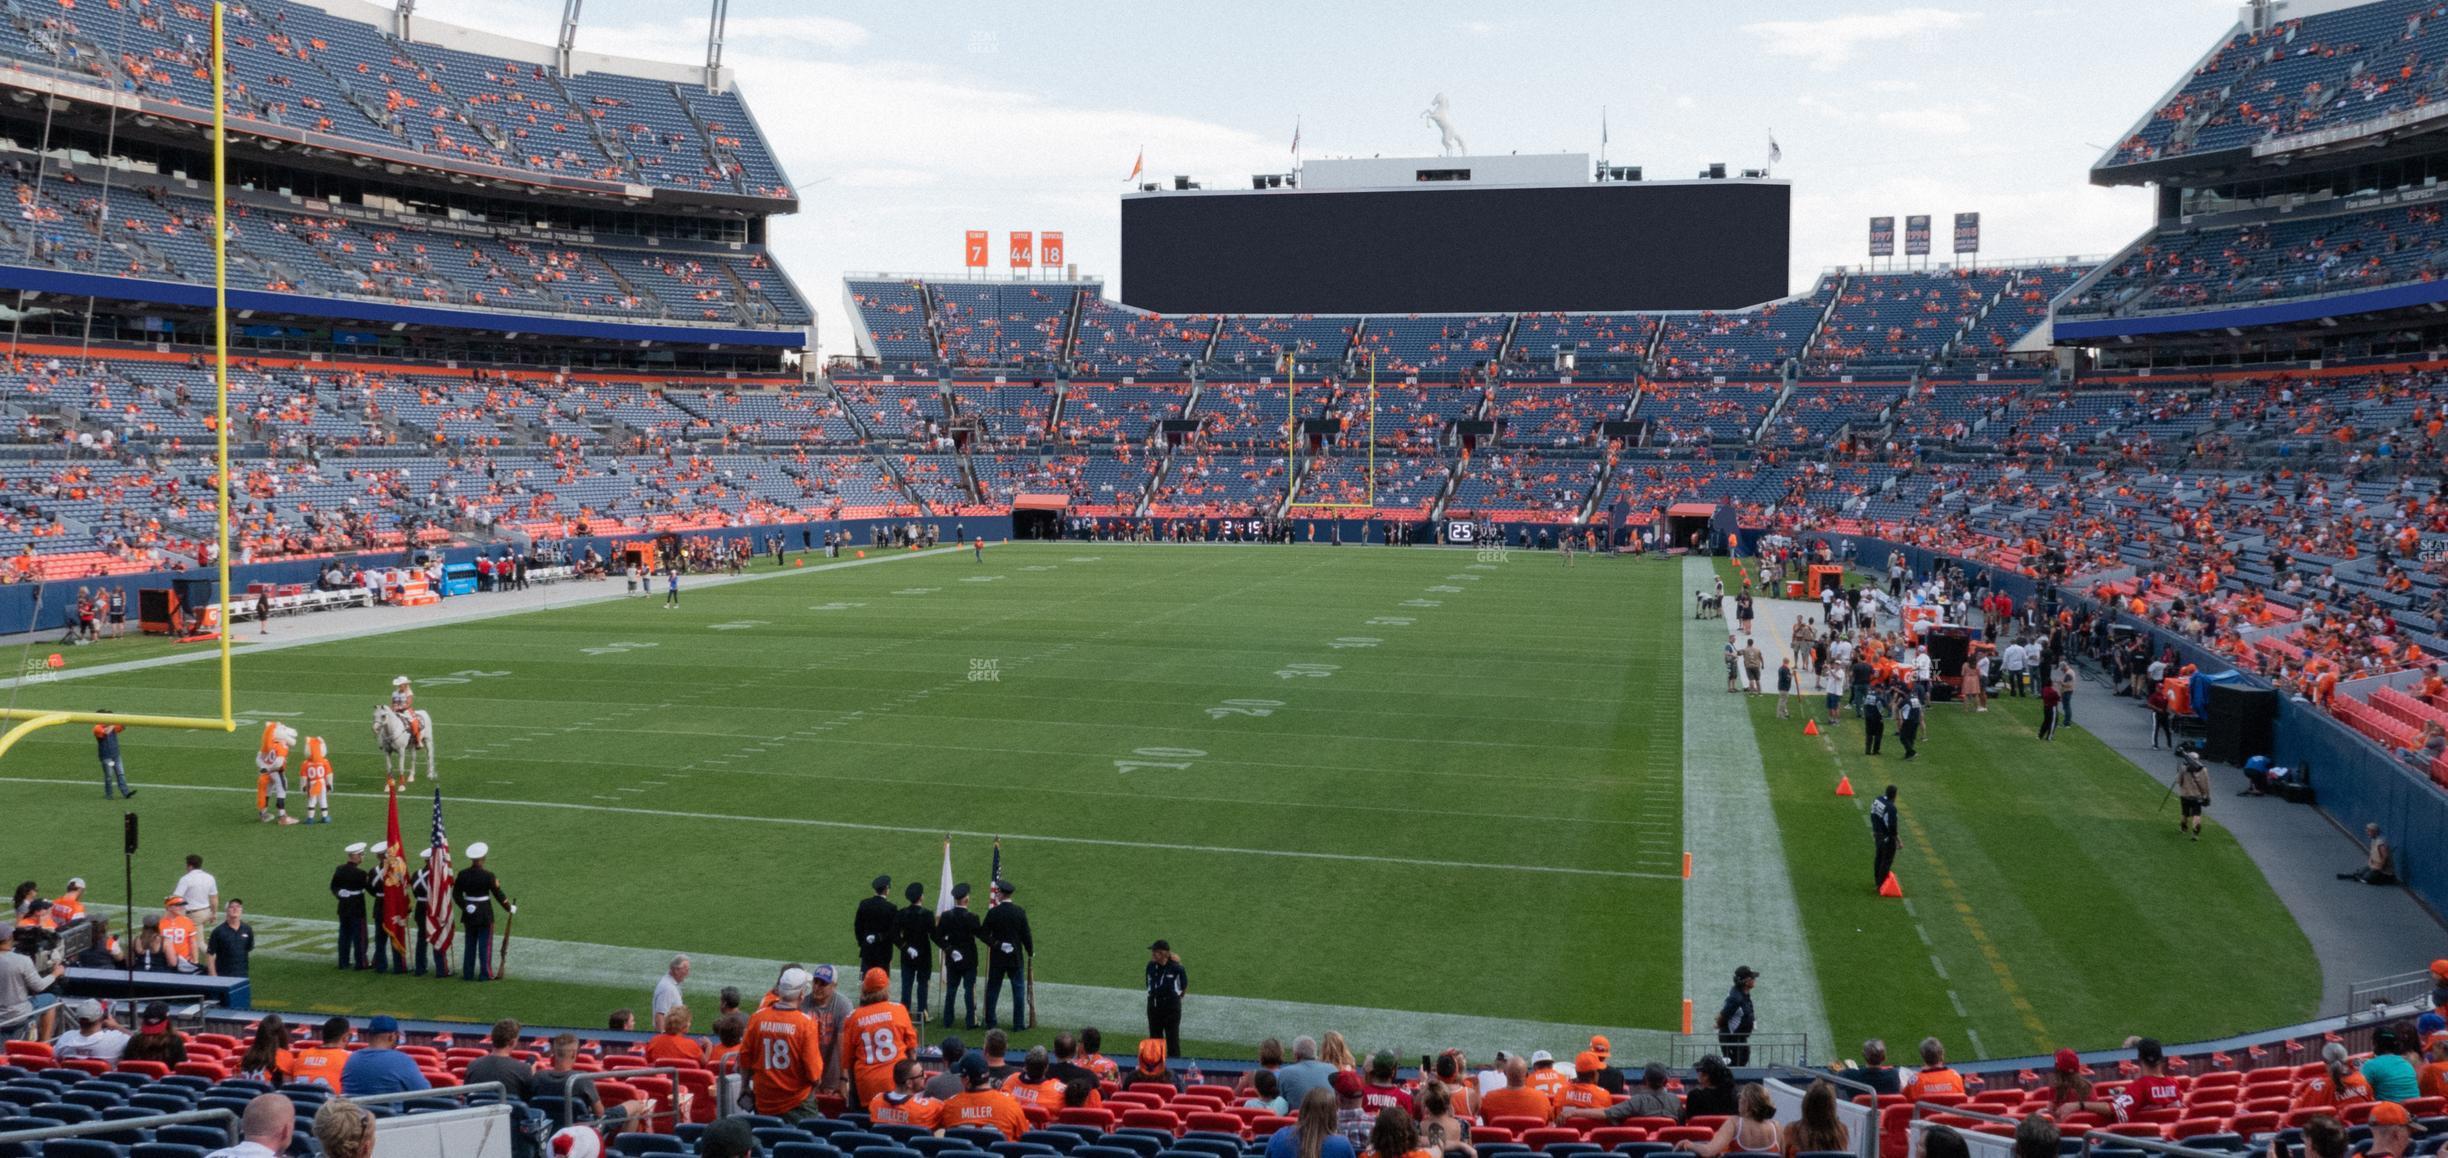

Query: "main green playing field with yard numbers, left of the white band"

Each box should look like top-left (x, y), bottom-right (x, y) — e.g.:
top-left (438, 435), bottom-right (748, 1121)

top-left (0, 544), bottom-right (1682, 1053)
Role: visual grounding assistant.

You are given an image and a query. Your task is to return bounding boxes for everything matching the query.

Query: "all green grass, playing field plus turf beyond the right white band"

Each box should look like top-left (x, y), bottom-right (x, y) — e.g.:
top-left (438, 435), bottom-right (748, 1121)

top-left (0, 544), bottom-right (2318, 1055)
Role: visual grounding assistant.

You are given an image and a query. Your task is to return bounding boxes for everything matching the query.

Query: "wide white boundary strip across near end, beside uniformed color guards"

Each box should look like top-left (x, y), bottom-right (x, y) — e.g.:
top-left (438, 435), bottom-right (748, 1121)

top-left (230, 913), bottom-right (1667, 1060)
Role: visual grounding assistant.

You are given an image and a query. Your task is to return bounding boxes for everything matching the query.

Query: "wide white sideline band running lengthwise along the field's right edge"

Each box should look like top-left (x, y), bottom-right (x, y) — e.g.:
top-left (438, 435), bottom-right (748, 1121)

top-left (1677, 558), bottom-right (1841, 1058)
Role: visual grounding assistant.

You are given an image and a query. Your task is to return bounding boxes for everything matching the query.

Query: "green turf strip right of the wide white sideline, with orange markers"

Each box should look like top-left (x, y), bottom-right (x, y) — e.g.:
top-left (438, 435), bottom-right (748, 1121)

top-left (1728, 583), bottom-right (2321, 1058)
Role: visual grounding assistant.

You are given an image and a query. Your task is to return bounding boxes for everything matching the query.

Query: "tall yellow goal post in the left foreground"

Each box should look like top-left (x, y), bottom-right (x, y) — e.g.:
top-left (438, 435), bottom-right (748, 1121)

top-left (0, 0), bottom-right (237, 756)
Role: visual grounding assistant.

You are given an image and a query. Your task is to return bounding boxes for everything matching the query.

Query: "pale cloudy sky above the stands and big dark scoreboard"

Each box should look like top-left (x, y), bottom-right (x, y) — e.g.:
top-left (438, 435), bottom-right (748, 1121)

top-left (419, 0), bottom-right (2235, 353)
